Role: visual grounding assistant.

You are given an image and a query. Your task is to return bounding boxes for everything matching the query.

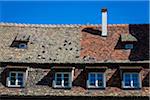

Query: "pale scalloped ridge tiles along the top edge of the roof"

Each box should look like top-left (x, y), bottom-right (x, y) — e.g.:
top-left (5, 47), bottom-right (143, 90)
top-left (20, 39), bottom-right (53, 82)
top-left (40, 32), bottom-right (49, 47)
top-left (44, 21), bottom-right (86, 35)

top-left (0, 22), bottom-right (128, 27)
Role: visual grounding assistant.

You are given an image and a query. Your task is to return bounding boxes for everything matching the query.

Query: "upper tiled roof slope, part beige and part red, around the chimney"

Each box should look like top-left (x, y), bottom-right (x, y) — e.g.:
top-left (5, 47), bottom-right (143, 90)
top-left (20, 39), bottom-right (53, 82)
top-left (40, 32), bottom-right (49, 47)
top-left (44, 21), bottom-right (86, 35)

top-left (0, 23), bottom-right (149, 63)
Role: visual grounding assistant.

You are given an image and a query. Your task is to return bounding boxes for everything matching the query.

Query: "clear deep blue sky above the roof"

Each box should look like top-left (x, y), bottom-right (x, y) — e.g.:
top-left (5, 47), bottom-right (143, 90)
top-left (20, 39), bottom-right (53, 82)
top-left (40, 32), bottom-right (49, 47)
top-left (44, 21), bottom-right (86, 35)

top-left (0, 1), bottom-right (149, 24)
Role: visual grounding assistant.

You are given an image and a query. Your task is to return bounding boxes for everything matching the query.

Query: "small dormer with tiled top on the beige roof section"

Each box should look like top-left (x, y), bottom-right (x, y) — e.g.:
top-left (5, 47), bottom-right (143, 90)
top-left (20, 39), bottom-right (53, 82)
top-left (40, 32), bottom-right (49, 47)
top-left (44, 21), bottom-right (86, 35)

top-left (11, 34), bottom-right (30, 49)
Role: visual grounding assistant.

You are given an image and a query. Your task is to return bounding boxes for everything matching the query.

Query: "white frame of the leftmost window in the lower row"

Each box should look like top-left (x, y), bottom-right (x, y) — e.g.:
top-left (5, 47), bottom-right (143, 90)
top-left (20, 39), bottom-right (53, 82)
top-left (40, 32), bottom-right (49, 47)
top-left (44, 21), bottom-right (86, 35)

top-left (6, 71), bottom-right (26, 87)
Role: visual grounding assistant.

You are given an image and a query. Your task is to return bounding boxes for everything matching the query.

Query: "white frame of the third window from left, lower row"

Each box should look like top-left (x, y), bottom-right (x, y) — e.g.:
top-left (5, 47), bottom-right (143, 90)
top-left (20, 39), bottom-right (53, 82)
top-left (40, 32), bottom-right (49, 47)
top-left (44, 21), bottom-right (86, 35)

top-left (87, 72), bottom-right (106, 88)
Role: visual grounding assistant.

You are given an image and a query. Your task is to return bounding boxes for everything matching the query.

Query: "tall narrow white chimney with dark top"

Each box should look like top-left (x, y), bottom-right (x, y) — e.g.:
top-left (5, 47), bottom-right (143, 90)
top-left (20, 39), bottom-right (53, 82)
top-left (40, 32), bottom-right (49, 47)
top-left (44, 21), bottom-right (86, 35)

top-left (101, 8), bottom-right (107, 36)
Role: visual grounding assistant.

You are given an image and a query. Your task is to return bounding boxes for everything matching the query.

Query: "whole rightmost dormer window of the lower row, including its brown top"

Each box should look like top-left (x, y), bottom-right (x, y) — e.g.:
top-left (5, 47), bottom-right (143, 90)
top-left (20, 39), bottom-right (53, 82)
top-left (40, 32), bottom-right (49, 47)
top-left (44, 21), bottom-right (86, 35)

top-left (120, 66), bottom-right (142, 89)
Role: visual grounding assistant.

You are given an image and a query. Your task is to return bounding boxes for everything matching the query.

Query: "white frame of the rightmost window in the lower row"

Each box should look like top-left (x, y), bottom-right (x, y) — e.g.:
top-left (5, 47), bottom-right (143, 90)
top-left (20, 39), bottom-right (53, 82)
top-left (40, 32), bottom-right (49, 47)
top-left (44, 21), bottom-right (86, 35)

top-left (122, 72), bottom-right (142, 89)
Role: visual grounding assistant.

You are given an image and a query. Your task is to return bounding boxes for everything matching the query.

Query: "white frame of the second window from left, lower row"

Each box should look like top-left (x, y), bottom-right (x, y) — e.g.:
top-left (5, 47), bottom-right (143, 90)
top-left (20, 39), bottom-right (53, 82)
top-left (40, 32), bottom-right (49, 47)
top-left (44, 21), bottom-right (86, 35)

top-left (53, 72), bottom-right (72, 88)
